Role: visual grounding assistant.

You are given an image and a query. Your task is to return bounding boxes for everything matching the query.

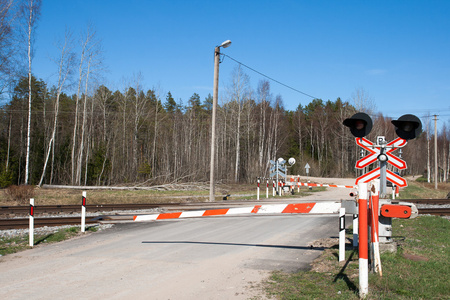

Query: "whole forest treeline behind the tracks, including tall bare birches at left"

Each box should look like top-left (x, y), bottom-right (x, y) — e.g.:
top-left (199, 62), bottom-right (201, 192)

top-left (0, 0), bottom-right (449, 187)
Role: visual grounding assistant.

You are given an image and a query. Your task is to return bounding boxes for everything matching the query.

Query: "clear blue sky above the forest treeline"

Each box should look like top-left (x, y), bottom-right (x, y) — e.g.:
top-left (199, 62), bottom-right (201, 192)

top-left (33, 0), bottom-right (450, 124)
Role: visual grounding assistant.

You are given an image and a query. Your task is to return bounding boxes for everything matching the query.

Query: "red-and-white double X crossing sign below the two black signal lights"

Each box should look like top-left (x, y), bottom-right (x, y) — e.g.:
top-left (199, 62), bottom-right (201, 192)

top-left (356, 138), bottom-right (408, 187)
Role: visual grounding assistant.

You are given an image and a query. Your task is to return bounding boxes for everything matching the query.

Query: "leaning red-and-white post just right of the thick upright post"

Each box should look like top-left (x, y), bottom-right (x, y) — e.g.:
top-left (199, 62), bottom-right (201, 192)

top-left (370, 179), bottom-right (382, 276)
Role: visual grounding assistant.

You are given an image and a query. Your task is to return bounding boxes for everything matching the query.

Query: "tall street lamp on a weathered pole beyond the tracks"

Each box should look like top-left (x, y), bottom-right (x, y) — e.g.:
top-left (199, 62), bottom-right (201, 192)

top-left (209, 40), bottom-right (231, 202)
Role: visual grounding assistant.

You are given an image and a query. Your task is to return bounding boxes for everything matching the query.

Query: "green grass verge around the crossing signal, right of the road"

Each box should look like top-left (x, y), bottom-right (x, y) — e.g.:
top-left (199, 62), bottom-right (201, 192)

top-left (264, 216), bottom-right (450, 299)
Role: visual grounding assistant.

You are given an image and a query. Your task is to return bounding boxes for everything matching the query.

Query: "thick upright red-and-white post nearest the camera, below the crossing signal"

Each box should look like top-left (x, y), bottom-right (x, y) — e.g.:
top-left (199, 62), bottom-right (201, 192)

top-left (358, 182), bottom-right (369, 298)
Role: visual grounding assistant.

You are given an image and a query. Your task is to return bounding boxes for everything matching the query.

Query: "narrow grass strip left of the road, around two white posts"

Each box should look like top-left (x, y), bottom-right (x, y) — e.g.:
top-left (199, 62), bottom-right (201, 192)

top-left (0, 226), bottom-right (97, 256)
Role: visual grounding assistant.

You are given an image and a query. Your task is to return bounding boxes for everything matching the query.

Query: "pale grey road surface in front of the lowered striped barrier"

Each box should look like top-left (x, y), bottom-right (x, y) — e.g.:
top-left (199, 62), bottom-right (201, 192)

top-left (0, 215), bottom-right (338, 299)
